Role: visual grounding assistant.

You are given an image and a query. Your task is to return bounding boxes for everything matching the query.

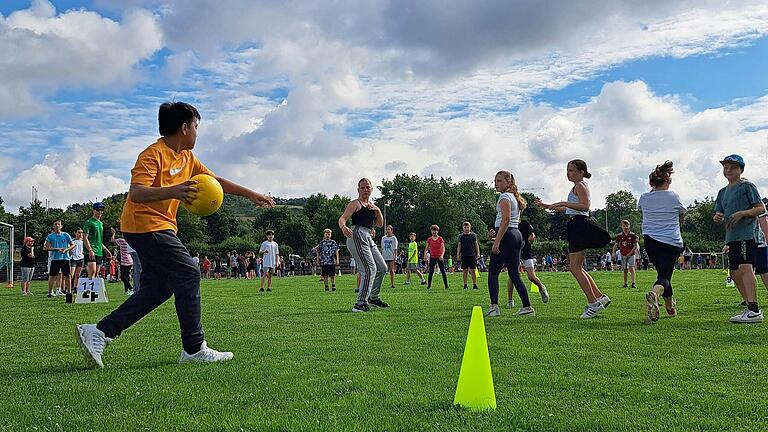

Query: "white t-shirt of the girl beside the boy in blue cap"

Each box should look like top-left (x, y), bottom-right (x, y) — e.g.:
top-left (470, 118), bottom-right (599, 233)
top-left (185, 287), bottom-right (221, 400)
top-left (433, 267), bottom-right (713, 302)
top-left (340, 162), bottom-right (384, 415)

top-left (637, 190), bottom-right (685, 247)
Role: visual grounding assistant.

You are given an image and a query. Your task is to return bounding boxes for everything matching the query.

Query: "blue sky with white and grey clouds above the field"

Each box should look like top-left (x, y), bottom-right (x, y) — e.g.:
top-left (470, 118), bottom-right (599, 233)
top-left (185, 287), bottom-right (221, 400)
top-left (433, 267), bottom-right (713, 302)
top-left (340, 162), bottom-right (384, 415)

top-left (0, 0), bottom-right (768, 211)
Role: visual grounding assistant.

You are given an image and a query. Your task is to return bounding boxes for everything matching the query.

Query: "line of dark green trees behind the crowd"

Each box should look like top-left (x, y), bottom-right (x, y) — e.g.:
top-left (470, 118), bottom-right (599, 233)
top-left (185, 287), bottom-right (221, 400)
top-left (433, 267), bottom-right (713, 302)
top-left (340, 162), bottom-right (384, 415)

top-left (0, 174), bottom-right (725, 257)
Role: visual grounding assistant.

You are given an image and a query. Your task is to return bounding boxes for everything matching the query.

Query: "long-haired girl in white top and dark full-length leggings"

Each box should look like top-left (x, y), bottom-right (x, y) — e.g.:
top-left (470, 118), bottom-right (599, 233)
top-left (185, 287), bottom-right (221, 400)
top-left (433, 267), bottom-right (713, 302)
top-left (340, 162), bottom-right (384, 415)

top-left (488, 171), bottom-right (536, 316)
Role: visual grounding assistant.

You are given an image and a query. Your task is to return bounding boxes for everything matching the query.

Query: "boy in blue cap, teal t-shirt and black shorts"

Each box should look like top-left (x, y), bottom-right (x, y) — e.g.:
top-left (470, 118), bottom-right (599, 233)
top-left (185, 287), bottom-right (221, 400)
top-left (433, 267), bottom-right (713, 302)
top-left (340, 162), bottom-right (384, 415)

top-left (712, 154), bottom-right (765, 323)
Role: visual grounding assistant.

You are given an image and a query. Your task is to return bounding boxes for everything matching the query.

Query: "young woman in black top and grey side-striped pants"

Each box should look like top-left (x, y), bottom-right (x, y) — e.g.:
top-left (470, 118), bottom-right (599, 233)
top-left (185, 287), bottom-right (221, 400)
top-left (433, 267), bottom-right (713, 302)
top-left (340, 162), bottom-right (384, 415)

top-left (338, 178), bottom-right (389, 312)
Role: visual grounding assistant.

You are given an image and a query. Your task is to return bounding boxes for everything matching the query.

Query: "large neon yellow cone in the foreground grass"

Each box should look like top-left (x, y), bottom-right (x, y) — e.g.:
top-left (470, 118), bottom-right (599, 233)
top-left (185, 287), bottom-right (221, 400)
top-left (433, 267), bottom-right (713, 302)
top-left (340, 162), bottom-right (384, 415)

top-left (453, 306), bottom-right (496, 410)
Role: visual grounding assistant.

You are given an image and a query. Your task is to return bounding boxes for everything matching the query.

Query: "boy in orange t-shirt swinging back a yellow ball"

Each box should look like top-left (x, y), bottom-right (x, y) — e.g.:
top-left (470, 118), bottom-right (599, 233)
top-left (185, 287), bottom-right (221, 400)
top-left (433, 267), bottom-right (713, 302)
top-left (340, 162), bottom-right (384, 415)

top-left (76, 102), bottom-right (274, 367)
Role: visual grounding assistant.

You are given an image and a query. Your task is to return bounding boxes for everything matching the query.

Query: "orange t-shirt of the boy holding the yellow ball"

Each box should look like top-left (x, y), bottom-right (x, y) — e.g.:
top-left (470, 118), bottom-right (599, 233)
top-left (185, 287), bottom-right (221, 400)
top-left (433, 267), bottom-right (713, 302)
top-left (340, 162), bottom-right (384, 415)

top-left (120, 138), bottom-right (214, 234)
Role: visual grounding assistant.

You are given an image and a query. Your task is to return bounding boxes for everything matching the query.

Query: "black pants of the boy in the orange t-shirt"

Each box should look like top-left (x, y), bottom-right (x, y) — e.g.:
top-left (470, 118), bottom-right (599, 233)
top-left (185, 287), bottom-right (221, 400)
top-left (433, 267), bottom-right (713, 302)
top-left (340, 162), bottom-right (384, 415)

top-left (97, 231), bottom-right (204, 354)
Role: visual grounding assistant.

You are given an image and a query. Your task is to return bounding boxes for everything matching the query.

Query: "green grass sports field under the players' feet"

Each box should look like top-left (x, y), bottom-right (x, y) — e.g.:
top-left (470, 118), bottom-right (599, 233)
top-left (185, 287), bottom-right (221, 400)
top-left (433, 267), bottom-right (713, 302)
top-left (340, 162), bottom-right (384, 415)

top-left (0, 270), bottom-right (768, 431)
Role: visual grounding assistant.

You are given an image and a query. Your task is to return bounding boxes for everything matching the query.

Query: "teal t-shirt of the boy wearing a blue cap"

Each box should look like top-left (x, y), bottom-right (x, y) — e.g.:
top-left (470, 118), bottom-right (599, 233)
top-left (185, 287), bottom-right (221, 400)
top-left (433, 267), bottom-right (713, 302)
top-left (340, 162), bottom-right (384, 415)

top-left (715, 179), bottom-right (763, 243)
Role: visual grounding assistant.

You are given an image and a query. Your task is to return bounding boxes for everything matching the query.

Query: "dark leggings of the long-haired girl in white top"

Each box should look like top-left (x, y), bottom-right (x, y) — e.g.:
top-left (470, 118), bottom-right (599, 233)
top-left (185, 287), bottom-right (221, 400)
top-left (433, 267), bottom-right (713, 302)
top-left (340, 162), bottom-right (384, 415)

top-left (488, 228), bottom-right (531, 307)
